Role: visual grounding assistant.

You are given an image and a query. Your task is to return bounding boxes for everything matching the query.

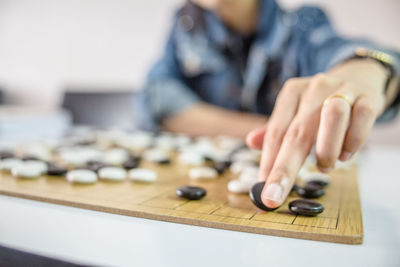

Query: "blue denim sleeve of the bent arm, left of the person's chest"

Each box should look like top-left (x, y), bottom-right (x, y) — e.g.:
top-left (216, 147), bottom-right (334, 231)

top-left (134, 13), bottom-right (200, 130)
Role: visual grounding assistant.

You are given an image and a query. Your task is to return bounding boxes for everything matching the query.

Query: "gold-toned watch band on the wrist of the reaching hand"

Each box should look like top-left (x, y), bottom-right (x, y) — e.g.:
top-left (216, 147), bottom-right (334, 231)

top-left (352, 47), bottom-right (395, 94)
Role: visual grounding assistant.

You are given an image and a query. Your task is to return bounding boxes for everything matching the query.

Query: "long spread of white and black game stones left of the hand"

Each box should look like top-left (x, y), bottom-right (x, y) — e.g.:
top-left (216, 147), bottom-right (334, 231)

top-left (0, 130), bottom-right (250, 186)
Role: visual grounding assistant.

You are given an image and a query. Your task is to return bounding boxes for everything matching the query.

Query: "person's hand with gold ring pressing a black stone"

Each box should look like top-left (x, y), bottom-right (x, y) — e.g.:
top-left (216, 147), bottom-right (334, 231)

top-left (247, 60), bottom-right (396, 208)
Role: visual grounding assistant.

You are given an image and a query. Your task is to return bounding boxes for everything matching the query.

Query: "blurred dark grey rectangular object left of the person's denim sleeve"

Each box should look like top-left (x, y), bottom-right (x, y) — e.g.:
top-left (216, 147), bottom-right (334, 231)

top-left (62, 88), bottom-right (134, 129)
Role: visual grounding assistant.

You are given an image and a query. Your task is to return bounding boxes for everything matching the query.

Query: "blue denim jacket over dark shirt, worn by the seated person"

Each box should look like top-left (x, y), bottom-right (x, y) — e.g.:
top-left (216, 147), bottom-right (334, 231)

top-left (134, 0), bottom-right (400, 130)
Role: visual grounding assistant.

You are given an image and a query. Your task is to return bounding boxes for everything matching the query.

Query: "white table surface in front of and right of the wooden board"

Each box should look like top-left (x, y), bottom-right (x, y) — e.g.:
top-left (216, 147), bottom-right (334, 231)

top-left (0, 144), bottom-right (400, 267)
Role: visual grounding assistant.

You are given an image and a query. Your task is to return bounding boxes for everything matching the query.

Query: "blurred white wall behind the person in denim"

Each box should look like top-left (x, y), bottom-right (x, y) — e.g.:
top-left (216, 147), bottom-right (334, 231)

top-left (0, 0), bottom-right (400, 106)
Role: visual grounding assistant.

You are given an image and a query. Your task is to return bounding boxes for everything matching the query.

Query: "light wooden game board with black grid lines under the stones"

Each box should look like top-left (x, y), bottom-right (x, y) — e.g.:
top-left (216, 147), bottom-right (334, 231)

top-left (0, 163), bottom-right (363, 244)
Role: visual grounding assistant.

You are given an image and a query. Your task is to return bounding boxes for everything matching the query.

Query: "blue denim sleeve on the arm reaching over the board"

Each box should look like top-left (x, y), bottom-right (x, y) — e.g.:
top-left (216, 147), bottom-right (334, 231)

top-left (290, 7), bottom-right (400, 121)
